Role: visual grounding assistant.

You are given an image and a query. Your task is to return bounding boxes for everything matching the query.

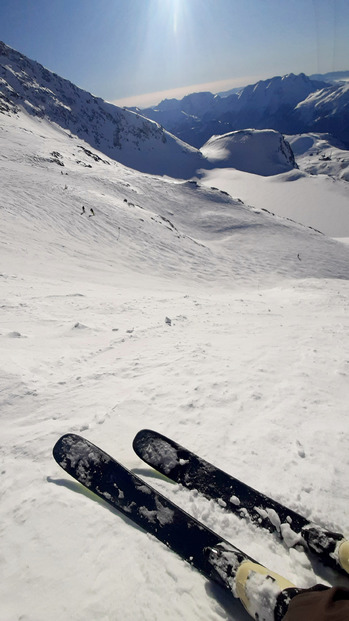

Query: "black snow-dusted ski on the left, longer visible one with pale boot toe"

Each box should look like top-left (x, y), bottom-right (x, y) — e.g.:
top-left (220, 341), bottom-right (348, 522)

top-left (53, 433), bottom-right (299, 621)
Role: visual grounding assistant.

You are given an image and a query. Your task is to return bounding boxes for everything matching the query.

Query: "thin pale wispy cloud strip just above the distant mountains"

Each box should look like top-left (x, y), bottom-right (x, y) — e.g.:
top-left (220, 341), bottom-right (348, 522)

top-left (111, 75), bottom-right (271, 108)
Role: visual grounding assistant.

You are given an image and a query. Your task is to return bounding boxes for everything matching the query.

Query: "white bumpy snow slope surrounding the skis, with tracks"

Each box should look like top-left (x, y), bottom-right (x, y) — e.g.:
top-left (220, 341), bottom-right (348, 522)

top-left (0, 112), bottom-right (349, 621)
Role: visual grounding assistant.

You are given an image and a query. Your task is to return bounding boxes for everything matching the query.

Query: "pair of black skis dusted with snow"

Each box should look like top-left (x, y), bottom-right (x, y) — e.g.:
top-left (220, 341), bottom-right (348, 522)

top-left (53, 429), bottom-right (349, 621)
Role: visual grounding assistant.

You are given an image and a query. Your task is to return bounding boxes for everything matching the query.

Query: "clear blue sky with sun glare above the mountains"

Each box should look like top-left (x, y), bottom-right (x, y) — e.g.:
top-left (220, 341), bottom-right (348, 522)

top-left (0, 0), bottom-right (349, 107)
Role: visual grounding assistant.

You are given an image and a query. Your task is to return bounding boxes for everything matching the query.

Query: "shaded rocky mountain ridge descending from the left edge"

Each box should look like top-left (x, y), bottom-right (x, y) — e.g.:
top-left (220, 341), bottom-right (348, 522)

top-left (0, 42), bottom-right (204, 178)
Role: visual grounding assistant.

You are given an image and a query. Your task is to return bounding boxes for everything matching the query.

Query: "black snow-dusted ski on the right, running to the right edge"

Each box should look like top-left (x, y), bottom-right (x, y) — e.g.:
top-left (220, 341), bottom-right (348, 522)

top-left (133, 429), bottom-right (349, 573)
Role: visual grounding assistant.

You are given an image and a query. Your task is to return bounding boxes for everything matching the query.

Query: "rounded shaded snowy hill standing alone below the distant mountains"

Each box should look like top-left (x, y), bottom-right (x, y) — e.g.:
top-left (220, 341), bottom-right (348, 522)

top-left (201, 129), bottom-right (297, 177)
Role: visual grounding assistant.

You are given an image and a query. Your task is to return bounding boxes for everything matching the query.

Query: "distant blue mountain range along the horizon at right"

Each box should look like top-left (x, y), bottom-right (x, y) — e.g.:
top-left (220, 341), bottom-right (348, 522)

top-left (141, 72), bottom-right (349, 148)
